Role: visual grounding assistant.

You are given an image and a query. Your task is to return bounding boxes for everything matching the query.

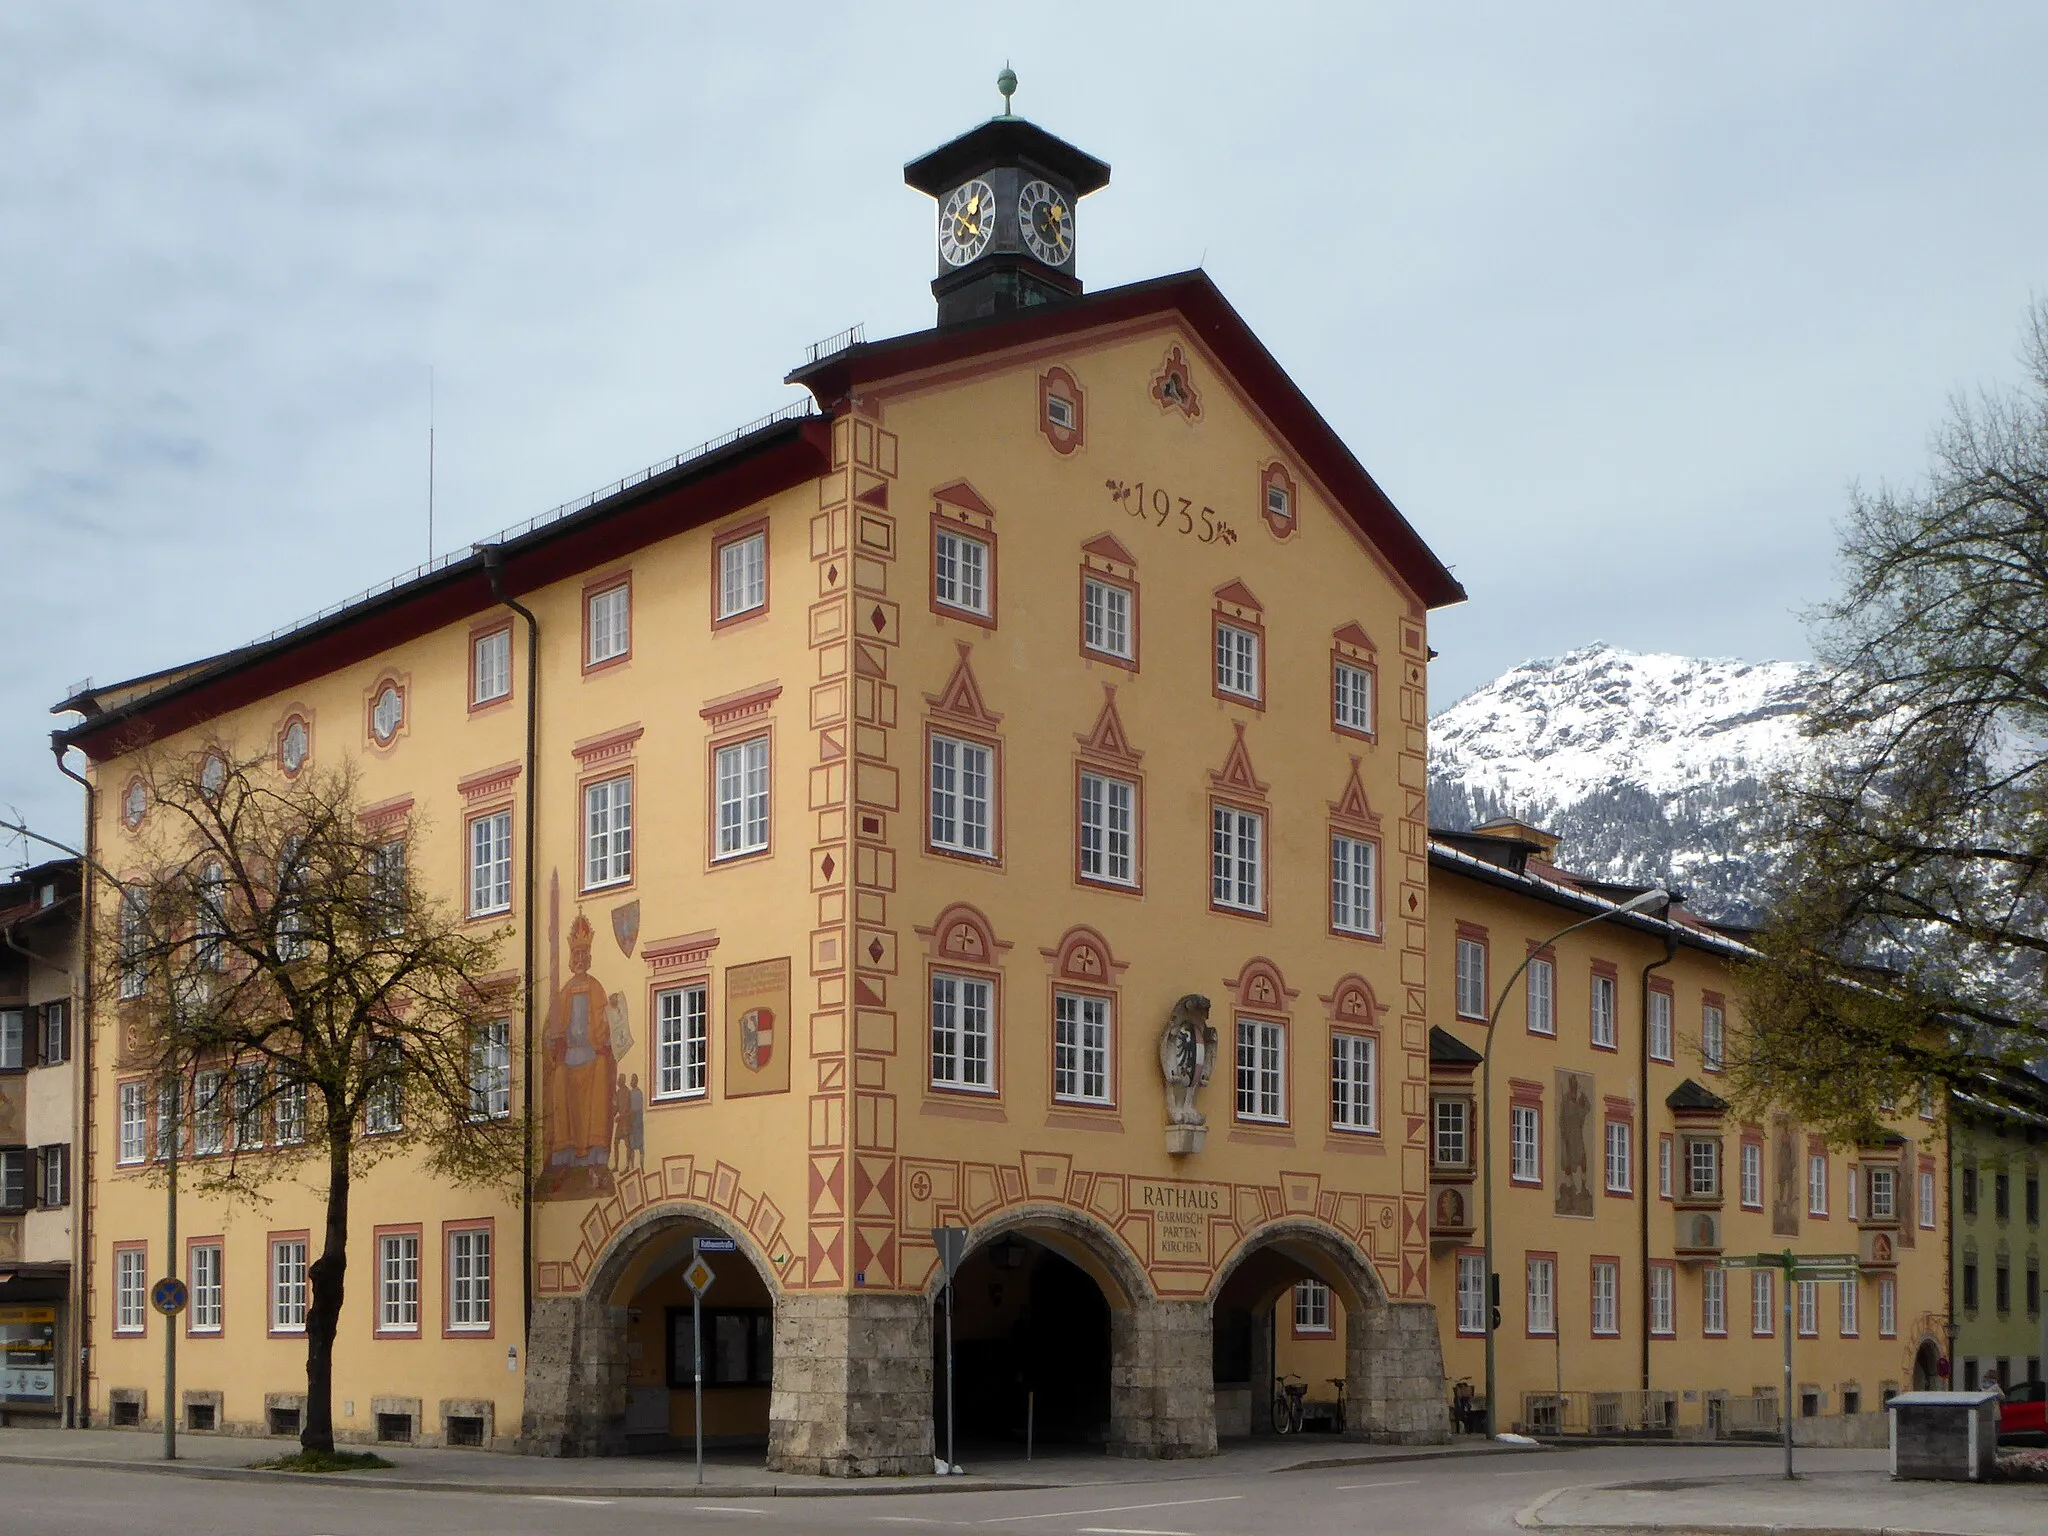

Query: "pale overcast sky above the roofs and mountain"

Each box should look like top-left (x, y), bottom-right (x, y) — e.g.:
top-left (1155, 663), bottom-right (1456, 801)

top-left (0, 0), bottom-right (2048, 866)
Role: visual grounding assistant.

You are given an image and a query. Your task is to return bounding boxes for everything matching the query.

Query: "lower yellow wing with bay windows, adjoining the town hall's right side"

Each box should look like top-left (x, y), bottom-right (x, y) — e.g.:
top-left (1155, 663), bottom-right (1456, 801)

top-left (1280, 821), bottom-right (1948, 1442)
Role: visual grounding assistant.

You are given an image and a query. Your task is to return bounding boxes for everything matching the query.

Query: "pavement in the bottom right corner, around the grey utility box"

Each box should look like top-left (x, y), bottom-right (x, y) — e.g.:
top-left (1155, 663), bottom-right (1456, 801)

top-left (1516, 1473), bottom-right (2048, 1536)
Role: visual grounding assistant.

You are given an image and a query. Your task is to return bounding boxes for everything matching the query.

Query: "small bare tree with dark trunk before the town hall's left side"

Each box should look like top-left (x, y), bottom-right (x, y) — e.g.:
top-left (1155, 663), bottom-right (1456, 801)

top-left (96, 745), bottom-right (522, 1452)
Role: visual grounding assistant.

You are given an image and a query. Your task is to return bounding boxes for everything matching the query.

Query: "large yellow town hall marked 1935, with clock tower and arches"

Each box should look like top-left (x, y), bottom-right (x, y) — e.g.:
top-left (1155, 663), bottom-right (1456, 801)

top-left (66, 102), bottom-right (1462, 1473)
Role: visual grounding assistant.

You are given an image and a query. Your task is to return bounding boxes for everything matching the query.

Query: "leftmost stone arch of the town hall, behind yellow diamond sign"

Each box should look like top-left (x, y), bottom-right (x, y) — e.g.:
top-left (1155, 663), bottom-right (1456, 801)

top-left (520, 1200), bottom-right (786, 1456)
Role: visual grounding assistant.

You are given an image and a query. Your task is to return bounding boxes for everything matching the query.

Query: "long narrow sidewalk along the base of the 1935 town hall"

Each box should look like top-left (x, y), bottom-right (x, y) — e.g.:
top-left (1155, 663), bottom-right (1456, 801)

top-left (0, 1427), bottom-right (1542, 1499)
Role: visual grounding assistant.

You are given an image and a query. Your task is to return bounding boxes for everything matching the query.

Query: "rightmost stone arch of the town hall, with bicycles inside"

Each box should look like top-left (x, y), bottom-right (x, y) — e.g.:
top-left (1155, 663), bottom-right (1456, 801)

top-left (1202, 1217), bottom-right (1450, 1444)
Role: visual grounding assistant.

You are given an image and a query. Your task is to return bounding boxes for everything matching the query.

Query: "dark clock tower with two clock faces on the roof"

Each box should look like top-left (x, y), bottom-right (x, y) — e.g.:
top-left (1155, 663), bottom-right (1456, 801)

top-left (903, 70), bottom-right (1110, 326)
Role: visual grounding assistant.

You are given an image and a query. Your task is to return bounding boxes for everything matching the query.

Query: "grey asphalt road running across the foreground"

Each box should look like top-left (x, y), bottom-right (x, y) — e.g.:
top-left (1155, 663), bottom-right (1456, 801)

top-left (0, 1448), bottom-right (1882, 1536)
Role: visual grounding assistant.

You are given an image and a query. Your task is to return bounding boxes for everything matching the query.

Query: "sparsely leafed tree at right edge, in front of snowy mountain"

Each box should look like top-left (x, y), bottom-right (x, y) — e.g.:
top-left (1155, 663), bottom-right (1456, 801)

top-left (1743, 305), bottom-right (2048, 1133)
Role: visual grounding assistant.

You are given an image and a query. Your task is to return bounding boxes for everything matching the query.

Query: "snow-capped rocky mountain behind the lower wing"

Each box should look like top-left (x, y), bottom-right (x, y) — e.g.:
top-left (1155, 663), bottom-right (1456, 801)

top-left (1430, 645), bottom-right (1819, 922)
